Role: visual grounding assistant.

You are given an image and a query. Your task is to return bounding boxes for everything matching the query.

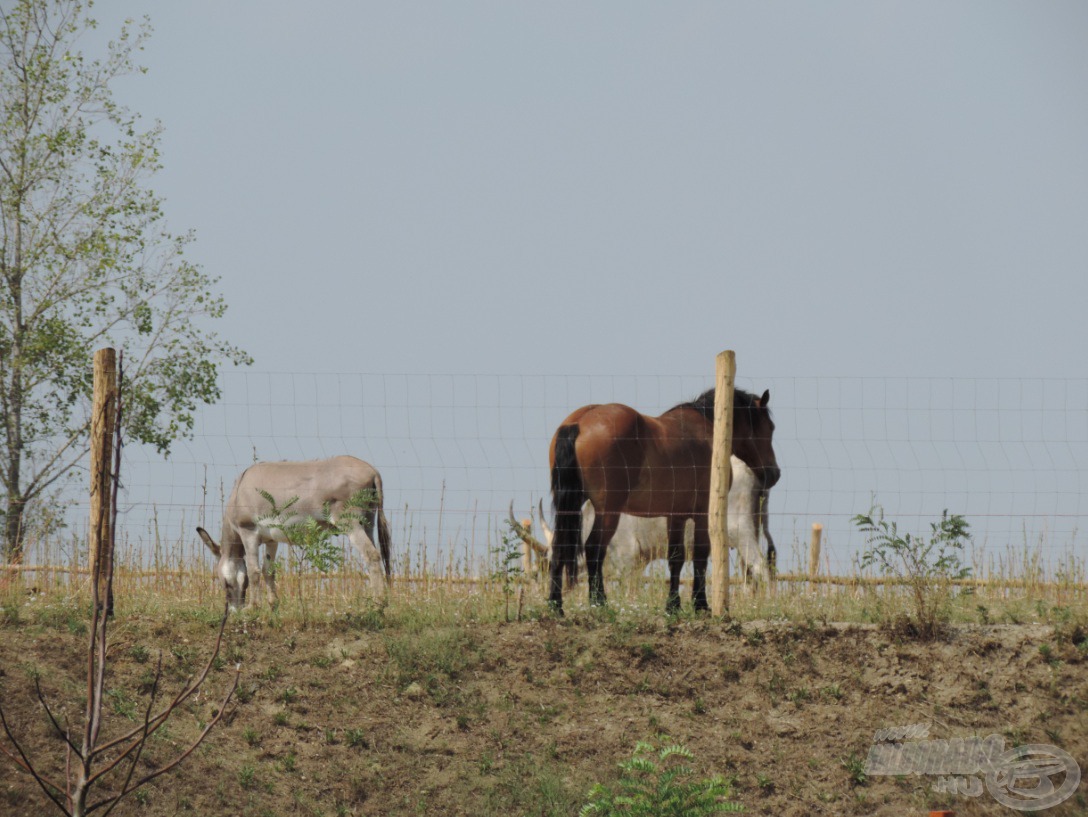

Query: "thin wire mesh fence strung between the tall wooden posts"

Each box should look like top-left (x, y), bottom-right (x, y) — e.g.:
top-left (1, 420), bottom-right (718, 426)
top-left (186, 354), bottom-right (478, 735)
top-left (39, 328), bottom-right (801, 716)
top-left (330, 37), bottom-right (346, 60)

top-left (14, 368), bottom-right (1088, 580)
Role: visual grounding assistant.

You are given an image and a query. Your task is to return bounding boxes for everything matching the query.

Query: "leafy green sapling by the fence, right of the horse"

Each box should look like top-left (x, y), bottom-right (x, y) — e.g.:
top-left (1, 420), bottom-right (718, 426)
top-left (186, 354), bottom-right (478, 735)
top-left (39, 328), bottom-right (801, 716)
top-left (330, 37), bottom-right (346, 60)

top-left (853, 505), bottom-right (970, 639)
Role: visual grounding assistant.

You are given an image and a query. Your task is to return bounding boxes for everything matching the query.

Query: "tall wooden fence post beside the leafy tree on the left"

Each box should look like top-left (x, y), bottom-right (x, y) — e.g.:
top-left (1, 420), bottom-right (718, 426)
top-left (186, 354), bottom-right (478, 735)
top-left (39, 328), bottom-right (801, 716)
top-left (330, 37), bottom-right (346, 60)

top-left (90, 348), bottom-right (118, 606)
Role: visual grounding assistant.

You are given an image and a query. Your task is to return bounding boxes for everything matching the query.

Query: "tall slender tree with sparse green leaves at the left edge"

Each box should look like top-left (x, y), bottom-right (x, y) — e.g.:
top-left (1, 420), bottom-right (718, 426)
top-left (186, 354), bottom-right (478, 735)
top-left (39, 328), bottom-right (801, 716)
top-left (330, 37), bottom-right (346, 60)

top-left (0, 0), bottom-right (251, 561)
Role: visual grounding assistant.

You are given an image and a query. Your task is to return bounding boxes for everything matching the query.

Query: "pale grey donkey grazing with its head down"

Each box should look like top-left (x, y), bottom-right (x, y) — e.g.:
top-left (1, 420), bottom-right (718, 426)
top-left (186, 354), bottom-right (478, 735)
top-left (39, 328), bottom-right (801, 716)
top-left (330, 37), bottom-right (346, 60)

top-left (197, 456), bottom-right (392, 608)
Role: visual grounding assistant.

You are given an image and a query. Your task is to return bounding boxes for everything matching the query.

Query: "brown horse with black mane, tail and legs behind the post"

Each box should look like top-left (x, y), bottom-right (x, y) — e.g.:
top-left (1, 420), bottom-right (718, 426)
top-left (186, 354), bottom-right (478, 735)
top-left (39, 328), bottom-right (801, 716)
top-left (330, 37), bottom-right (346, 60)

top-left (548, 388), bottom-right (781, 612)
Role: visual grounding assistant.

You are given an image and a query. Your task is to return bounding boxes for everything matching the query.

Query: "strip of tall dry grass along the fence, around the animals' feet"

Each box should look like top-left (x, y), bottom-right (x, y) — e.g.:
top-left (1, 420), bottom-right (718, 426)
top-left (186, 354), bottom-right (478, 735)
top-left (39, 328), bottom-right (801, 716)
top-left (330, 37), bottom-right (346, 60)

top-left (0, 520), bottom-right (1088, 623)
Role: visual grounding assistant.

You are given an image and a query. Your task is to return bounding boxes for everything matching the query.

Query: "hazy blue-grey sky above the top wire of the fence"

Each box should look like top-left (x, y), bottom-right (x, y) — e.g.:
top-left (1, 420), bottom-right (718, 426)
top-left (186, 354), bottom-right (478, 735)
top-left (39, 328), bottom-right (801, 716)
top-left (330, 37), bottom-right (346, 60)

top-left (97, 0), bottom-right (1088, 376)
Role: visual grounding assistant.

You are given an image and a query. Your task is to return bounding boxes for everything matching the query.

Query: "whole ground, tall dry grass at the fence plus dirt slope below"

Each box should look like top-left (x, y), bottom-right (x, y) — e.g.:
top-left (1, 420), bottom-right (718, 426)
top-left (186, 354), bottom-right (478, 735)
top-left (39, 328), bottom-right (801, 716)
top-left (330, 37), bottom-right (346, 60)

top-left (0, 530), bottom-right (1088, 817)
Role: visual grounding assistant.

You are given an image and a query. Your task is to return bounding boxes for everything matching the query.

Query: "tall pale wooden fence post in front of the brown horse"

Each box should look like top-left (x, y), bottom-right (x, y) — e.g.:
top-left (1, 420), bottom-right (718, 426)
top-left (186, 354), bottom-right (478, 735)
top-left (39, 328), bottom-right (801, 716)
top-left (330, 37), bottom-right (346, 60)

top-left (708, 350), bottom-right (737, 616)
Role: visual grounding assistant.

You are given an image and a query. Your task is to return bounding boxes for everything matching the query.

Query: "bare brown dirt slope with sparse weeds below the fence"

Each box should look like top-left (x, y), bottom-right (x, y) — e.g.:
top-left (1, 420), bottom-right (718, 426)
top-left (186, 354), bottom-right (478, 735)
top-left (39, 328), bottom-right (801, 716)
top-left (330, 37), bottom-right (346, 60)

top-left (0, 607), bottom-right (1088, 817)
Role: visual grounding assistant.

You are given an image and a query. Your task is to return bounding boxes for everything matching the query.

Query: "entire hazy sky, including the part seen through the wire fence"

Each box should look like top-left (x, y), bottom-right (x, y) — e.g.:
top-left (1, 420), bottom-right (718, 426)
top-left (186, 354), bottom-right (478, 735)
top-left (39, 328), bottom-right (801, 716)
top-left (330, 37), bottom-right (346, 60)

top-left (63, 0), bottom-right (1088, 583)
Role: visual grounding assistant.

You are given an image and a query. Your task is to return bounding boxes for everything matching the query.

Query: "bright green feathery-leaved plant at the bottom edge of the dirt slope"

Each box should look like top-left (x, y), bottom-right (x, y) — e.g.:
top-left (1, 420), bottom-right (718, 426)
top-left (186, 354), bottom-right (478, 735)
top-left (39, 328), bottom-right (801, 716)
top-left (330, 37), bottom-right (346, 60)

top-left (579, 735), bottom-right (743, 817)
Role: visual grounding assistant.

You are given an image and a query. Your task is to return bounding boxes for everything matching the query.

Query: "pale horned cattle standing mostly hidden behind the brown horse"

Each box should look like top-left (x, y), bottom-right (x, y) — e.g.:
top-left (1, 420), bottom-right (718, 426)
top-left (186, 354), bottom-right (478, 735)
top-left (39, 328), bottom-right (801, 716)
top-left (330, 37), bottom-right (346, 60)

top-left (510, 457), bottom-right (770, 580)
